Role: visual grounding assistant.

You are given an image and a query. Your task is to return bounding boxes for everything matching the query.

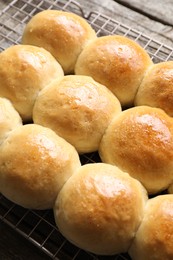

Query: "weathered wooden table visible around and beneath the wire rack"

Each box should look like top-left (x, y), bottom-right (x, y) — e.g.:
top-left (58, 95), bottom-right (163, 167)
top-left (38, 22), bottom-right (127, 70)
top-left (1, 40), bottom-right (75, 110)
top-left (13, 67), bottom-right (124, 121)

top-left (0, 0), bottom-right (173, 260)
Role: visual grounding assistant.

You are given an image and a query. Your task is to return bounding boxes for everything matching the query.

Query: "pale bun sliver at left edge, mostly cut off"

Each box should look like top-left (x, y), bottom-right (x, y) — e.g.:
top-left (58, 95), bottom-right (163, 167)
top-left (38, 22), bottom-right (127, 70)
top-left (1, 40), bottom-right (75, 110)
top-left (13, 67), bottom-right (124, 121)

top-left (0, 98), bottom-right (22, 144)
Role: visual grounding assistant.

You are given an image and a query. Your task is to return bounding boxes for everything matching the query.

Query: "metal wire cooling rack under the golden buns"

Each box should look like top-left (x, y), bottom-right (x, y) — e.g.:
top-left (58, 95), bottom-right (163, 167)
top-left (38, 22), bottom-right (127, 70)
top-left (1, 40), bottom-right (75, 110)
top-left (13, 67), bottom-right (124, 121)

top-left (0, 0), bottom-right (173, 260)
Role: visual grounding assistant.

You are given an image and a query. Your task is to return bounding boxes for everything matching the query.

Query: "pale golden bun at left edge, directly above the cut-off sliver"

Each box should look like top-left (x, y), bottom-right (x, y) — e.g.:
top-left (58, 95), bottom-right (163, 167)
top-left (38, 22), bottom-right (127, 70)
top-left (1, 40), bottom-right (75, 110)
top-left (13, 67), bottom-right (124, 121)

top-left (0, 45), bottom-right (63, 121)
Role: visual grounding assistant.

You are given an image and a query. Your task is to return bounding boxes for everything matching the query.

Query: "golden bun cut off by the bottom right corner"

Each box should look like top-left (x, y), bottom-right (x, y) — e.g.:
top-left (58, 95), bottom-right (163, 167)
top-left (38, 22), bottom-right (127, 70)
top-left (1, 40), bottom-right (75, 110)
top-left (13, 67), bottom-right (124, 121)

top-left (129, 195), bottom-right (173, 260)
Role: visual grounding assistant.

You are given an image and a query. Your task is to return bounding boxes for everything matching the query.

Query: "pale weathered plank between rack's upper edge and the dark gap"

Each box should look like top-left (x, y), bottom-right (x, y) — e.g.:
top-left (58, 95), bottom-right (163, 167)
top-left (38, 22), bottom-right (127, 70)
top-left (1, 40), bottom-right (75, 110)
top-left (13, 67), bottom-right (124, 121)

top-left (78, 0), bottom-right (173, 47)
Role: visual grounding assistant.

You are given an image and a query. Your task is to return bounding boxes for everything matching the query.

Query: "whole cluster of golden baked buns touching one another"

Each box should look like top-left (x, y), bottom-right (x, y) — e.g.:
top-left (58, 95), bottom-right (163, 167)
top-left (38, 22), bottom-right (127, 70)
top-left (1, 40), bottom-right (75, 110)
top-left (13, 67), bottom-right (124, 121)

top-left (0, 10), bottom-right (173, 260)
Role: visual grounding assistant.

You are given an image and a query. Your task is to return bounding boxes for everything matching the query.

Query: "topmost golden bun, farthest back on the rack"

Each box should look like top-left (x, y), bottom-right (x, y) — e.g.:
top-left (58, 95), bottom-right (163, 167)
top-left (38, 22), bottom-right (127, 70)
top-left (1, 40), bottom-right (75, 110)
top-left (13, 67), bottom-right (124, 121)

top-left (22, 10), bottom-right (96, 74)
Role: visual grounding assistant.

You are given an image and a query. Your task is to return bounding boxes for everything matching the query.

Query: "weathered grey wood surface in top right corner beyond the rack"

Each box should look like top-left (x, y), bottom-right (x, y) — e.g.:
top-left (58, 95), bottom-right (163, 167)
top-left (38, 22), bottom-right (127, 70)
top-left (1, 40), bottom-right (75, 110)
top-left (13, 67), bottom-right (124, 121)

top-left (78, 0), bottom-right (173, 47)
